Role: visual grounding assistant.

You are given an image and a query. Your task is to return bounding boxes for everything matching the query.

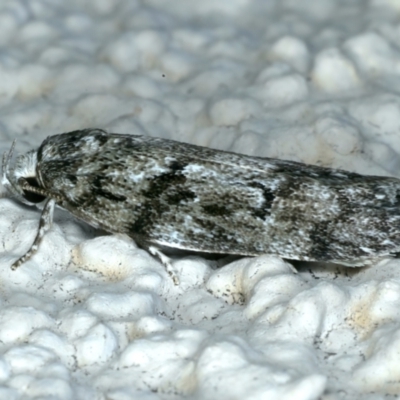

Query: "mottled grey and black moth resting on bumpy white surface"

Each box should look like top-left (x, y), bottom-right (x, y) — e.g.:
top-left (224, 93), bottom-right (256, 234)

top-left (2, 129), bottom-right (400, 282)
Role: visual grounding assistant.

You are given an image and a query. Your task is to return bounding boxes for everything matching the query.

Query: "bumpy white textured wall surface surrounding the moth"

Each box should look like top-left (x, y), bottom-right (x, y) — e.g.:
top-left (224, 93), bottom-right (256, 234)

top-left (0, 0), bottom-right (400, 400)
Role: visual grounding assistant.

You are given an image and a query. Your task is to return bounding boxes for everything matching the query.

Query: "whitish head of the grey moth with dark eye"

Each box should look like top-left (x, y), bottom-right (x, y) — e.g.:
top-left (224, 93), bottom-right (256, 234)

top-left (2, 141), bottom-right (47, 205)
